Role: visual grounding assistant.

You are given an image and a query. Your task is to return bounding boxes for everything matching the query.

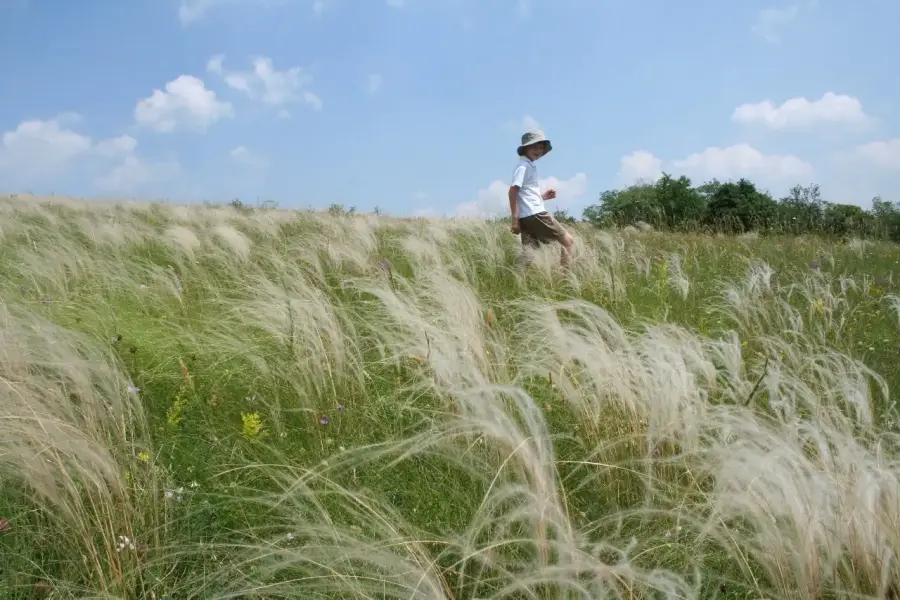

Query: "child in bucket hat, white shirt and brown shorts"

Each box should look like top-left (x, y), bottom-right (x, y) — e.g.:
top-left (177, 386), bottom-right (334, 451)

top-left (509, 131), bottom-right (574, 267)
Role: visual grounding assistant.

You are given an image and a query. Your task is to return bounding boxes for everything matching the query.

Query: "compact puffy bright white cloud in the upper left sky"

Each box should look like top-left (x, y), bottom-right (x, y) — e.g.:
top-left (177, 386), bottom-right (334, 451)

top-left (134, 75), bottom-right (234, 132)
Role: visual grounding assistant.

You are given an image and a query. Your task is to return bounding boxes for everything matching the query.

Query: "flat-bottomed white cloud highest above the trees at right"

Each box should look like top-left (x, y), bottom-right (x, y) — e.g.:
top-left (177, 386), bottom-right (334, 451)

top-left (731, 92), bottom-right (869, 130)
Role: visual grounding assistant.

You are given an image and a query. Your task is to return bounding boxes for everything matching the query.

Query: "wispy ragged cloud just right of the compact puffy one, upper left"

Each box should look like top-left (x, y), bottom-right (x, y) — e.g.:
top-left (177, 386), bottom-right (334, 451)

top-left (206, 54), bottom-right (322, 110)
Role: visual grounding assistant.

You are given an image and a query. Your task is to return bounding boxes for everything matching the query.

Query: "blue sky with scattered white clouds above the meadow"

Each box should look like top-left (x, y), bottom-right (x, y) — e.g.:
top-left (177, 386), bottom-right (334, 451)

top-left (0, 0), bottom-right (900, 215)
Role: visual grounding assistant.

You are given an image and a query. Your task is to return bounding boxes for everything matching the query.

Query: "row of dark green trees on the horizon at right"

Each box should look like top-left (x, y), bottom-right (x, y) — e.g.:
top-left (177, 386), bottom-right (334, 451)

top-left (556, 173), bottom-right (900, 242)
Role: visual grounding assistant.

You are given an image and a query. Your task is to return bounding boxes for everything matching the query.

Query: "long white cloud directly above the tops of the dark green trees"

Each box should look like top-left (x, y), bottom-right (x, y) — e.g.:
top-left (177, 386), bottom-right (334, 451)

top-left (672, 144), bottom-right (813, 184)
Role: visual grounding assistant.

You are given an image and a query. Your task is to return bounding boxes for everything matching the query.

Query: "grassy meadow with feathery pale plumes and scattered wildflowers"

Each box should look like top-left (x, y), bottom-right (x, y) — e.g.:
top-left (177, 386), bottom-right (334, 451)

top-left (0, 197), bottom-right (900, 600)
